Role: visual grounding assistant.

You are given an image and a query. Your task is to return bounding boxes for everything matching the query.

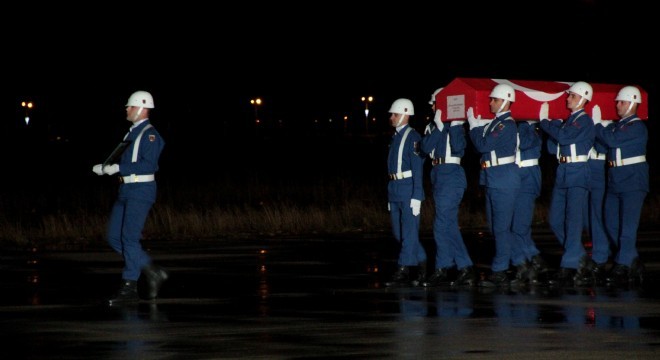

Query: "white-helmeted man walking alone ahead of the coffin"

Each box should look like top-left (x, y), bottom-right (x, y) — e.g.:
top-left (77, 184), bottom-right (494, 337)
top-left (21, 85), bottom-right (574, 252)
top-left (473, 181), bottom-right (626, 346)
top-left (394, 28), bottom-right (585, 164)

top-left (92, 91), bottom-right (168, 306)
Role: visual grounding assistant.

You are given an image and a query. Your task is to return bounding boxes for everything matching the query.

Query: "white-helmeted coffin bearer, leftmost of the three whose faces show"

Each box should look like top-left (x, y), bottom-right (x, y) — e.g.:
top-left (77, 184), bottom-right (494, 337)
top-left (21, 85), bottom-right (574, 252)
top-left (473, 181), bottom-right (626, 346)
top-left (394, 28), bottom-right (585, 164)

top-left (467, 84), bottom-right (520, 286)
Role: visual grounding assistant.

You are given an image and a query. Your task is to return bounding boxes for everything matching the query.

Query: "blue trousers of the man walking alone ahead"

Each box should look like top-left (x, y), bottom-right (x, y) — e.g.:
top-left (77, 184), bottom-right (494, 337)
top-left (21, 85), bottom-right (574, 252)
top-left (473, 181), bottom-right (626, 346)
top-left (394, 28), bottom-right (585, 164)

top-left (108, 197), bottom-right (153, 281)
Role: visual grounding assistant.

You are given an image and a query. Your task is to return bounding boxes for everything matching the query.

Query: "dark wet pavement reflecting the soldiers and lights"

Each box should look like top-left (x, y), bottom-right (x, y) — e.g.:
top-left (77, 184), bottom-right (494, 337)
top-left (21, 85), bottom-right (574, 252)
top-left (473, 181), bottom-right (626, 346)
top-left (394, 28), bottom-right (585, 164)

top-left (0, 231), bottom-right (660, 359)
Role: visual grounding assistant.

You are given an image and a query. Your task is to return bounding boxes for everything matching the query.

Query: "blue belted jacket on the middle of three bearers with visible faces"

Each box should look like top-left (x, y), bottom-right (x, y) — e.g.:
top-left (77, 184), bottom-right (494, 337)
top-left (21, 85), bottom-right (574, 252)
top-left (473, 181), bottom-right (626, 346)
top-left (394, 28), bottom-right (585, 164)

top-left (541, 109), bottom-right (596, 189)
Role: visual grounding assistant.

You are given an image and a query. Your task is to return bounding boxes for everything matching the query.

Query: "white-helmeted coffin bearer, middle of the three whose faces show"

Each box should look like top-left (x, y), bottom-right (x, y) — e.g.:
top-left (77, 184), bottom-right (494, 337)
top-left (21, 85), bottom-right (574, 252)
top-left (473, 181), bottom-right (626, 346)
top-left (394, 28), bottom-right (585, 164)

top-left (539, 81), bottom-right (595, 285)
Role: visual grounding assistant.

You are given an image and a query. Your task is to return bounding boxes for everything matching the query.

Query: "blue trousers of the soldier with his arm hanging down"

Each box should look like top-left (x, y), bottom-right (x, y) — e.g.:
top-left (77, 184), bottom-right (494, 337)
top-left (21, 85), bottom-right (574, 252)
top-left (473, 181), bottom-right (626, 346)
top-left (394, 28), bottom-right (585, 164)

top-left (390, 201), bottom-right (426, 266)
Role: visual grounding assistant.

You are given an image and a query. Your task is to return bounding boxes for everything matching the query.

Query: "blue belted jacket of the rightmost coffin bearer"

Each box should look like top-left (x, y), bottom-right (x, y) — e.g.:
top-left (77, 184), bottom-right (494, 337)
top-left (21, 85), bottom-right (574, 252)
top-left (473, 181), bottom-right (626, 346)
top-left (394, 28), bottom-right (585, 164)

top-left (596, 115), bottom-right (649, 193)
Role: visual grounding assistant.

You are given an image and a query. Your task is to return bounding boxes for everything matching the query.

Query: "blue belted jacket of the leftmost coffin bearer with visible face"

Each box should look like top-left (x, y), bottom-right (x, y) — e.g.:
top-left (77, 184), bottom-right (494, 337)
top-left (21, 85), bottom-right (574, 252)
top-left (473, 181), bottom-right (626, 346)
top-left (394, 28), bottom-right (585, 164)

top-left (470, 111), bottom-right (520, 189)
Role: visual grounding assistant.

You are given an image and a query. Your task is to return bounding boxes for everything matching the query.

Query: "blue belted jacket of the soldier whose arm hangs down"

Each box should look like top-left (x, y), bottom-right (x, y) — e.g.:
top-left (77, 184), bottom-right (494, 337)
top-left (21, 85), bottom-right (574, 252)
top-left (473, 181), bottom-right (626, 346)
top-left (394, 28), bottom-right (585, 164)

top-left (387, 125), bottom-right (424, 201)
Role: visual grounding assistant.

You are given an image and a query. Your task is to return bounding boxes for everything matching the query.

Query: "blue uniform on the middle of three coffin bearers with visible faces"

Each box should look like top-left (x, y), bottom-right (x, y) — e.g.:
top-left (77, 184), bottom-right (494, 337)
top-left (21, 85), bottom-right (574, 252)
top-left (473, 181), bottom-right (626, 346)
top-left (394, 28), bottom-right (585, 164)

top-left (540, 109), bottom-right (595, 269)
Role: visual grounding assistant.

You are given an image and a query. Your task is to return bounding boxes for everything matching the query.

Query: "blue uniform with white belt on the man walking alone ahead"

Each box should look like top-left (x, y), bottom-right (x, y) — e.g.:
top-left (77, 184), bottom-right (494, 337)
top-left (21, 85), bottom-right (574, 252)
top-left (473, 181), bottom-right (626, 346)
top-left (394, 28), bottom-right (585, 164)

top-left (108, 119), bottom-right (165, 280)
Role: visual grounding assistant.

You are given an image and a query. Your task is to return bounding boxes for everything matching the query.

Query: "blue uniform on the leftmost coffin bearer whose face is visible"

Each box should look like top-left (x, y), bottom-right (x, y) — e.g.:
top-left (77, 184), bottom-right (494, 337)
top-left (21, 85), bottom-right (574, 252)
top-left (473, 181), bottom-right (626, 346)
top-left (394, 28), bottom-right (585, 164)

top-left (470, 111), bottom-right (520, 272)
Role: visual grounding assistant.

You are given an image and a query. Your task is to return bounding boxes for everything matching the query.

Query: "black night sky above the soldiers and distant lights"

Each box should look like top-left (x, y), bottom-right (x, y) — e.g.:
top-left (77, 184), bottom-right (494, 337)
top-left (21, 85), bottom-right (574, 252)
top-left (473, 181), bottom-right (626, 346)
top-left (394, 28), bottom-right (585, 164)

top-left (0, 0), bottom-right (660, 186)
